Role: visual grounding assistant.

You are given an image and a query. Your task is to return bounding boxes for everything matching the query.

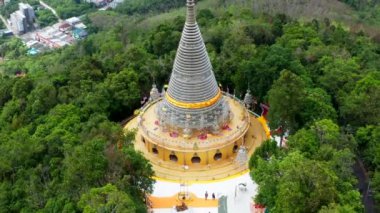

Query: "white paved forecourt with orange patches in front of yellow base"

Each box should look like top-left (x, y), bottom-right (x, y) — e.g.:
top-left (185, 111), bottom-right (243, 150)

top-left (150, 172), bottom-right (257, 213)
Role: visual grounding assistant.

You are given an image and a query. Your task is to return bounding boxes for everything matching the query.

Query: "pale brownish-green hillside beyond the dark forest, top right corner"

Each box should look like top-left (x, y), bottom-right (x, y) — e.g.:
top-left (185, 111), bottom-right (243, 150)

top-left (232, 0), bottom-right (380, 38)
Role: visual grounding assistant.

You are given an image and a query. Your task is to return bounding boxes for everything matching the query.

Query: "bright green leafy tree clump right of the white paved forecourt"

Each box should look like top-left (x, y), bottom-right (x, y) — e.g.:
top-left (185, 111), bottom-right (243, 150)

top-left (250, 120), bottom-right (363, 212)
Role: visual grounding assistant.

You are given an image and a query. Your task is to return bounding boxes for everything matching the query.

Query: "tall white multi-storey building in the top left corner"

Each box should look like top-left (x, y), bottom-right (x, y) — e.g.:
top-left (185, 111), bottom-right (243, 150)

top-left (10, 3), bottom-right (36, 34)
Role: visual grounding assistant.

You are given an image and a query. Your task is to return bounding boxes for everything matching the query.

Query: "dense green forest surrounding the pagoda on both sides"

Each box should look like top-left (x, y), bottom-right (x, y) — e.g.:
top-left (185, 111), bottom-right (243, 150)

top-left (0, 1), bottom-right (380, 212)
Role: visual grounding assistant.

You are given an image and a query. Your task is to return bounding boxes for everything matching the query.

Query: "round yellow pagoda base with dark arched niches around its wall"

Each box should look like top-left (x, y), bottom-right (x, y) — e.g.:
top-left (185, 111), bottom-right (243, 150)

top-left (124, 97), bottom-right (268, 182)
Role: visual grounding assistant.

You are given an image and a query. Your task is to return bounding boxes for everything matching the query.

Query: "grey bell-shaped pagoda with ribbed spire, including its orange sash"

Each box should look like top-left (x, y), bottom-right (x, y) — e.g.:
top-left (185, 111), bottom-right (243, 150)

top-left (156, 0), bottom-right (230, 136)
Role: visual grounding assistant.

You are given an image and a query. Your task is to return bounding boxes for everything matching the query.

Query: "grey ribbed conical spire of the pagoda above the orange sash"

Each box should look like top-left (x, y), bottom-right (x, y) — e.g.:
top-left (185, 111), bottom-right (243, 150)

top-left (167, 1), bottom-right (219, 103)
